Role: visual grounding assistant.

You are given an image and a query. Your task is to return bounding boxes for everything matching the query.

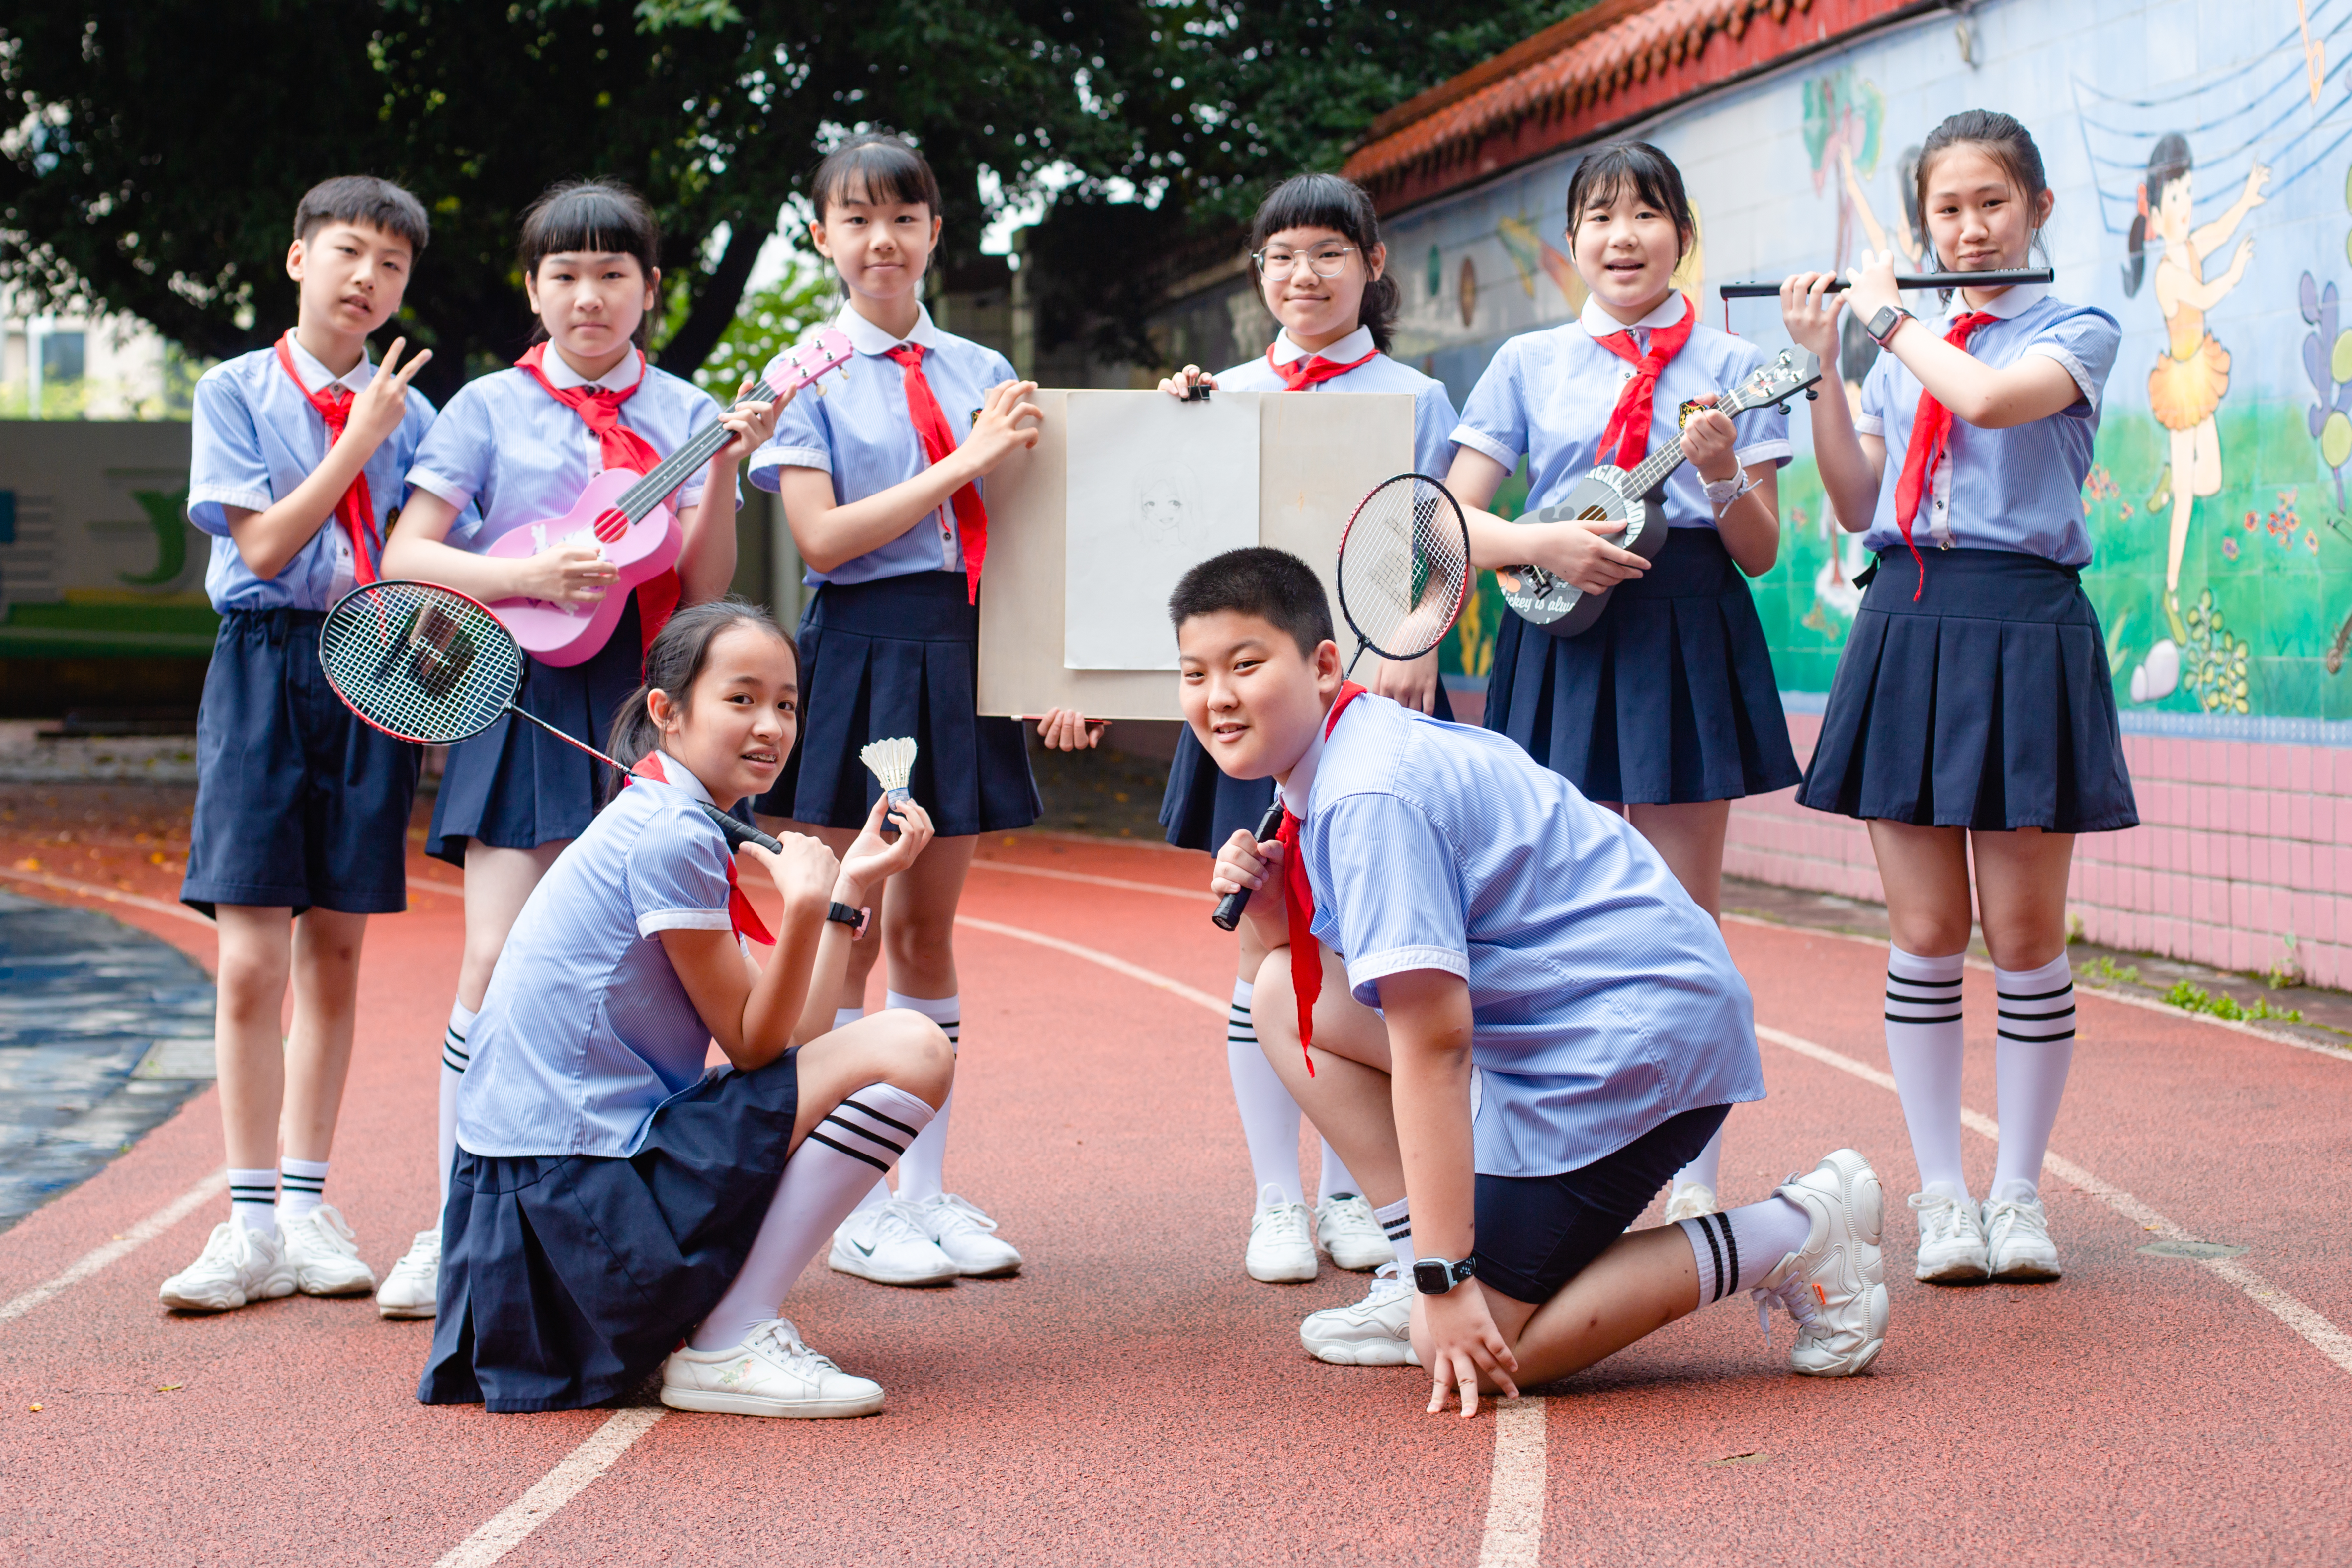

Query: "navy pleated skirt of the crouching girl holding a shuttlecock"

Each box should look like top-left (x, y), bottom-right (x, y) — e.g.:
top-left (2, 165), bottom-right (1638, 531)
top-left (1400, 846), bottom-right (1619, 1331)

top-left (417, 1051), bottom-right (800, 1410)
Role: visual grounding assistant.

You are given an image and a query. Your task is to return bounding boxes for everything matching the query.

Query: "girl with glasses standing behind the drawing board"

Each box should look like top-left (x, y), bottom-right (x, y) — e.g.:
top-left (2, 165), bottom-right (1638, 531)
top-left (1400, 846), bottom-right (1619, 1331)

top-left (1160, 174), bottom-right (1453, 1281)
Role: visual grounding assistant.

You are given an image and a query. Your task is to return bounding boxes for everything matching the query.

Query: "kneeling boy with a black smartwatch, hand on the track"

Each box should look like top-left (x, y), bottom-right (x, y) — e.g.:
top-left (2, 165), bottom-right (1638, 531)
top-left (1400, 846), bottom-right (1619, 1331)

top-left (1169, 548), bottom-right (1886, 1415)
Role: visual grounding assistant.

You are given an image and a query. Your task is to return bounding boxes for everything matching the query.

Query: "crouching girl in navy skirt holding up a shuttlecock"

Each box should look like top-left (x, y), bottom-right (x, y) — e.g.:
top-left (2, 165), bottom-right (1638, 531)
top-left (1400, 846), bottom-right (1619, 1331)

top-left (417, 599), bottom-right (955, 1417)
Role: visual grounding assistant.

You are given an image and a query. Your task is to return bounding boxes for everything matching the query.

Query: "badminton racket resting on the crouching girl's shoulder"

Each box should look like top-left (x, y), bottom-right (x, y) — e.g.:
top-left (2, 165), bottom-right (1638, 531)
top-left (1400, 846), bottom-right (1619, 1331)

top-left (318, 578), bottom-right (783, 853)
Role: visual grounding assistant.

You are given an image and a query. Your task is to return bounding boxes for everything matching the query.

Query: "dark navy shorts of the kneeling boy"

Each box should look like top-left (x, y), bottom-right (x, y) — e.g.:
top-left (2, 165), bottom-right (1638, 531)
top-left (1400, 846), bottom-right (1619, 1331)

top-left (1475, 1105), bottom-right (1731, 1305)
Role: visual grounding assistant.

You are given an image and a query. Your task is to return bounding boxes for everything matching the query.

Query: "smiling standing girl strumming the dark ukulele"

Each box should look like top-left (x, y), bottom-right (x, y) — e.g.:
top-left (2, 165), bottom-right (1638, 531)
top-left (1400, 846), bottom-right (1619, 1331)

top-left (1451, 141), bottom-right (1799, 1220)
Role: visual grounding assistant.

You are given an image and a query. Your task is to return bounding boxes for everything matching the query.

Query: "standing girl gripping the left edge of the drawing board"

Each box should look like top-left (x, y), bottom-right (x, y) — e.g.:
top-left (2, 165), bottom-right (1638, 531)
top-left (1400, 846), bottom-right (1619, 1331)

top-left (751, 134), bottom-right (1068, 1286)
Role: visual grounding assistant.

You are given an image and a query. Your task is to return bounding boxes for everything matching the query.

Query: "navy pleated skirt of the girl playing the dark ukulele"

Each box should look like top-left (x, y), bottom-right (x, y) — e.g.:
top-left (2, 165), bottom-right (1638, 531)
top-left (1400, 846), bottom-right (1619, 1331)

top-left (1487, 529), bottom-right (1802, 804)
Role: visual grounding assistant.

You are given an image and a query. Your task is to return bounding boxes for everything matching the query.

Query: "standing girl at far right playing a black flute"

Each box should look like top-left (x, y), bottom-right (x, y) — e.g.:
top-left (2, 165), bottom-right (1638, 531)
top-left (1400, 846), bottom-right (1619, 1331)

top-left (1780, 110), bottom-right (2140, 1281)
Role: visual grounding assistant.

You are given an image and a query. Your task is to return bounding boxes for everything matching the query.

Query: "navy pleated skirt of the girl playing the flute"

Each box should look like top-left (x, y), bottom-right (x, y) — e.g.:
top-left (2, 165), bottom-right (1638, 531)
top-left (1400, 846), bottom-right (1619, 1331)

top-left (1797, 550), bottom-right (2140, 832)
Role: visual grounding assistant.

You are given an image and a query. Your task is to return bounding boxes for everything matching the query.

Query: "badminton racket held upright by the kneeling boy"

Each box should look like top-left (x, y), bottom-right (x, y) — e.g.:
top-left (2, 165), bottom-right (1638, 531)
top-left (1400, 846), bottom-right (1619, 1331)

top-left (1209, 473), bottom-right (1470, 931)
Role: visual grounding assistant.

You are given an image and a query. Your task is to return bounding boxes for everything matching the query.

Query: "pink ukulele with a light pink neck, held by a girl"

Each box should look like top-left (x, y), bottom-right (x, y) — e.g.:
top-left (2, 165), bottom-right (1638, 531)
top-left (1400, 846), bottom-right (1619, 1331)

top-left (485, 327), bottom-right (856, 667)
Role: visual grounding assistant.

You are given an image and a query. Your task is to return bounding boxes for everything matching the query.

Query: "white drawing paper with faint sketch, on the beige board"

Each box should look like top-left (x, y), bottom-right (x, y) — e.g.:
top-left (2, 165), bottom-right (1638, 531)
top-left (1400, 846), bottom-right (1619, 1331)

top-left (1061, 393), bottom-right (1259, 670)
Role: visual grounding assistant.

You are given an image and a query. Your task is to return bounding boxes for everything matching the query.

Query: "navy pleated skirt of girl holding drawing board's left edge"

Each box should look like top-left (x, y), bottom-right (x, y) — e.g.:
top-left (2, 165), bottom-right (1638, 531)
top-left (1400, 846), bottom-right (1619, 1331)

top-left (757, 571), bottom-right (1044, 839)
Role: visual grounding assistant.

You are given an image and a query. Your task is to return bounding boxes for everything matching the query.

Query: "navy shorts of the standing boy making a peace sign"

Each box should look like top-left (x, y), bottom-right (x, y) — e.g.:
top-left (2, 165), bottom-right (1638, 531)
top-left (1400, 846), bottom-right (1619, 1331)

top-left (179, 609), bottom-right (423, 914)
